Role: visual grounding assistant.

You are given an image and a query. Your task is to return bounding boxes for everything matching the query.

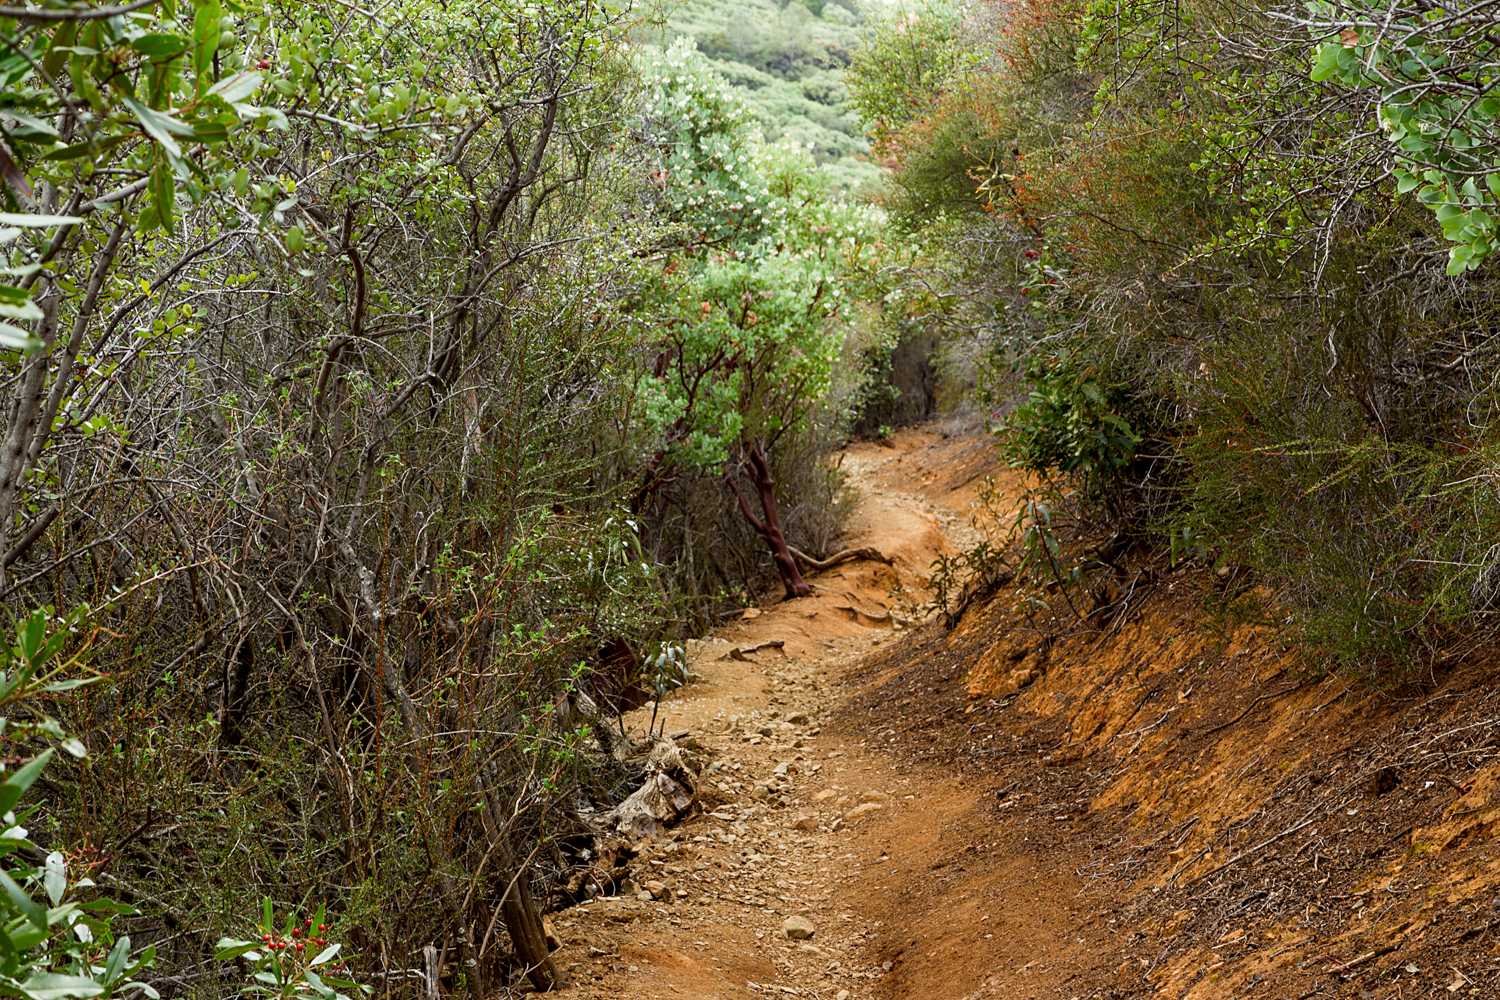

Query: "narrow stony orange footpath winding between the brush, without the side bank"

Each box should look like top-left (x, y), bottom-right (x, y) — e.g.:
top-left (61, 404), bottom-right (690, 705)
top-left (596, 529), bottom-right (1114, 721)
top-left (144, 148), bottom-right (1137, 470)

top-left (551, 432), bottom-right (1050, 1000)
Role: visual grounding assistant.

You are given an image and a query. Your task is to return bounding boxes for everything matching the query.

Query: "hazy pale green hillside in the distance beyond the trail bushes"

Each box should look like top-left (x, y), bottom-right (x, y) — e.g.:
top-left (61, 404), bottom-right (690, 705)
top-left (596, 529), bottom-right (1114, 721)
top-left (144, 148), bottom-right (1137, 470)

top-left (644, 0), bottom-right (881, 190)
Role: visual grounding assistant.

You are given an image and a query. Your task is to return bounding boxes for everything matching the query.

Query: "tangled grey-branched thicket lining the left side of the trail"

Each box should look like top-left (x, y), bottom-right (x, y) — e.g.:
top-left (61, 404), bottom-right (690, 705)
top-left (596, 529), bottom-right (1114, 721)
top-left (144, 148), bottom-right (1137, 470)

top-left (0, 0), bottom-right (879, 997)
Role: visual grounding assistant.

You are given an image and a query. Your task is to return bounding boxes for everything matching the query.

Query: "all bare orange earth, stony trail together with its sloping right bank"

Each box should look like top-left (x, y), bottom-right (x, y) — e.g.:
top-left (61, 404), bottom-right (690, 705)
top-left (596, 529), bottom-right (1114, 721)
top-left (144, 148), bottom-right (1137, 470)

top-left (551, 432), bottom-right (1500, 1000)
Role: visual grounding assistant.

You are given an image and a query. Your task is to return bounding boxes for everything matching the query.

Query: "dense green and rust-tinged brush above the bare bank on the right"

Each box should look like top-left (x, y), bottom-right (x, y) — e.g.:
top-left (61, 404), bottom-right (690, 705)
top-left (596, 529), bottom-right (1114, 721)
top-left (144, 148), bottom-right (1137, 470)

top-left (851, 0), bottom-right (1500, 678)
